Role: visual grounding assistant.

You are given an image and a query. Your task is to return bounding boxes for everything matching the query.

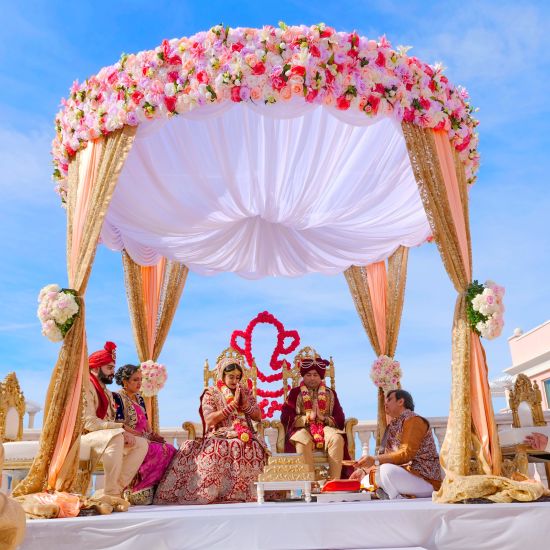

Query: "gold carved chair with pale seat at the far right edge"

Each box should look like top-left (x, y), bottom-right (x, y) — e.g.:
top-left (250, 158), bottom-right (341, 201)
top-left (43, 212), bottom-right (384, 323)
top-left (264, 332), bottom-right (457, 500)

top-left (499, 374), bottom-right (550, 479)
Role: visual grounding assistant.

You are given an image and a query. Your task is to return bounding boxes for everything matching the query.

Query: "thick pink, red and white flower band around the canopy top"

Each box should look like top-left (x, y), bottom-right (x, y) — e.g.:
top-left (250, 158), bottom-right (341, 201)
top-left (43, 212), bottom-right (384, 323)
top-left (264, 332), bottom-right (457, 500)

top-left (52, 23), bottom-right (479, 204)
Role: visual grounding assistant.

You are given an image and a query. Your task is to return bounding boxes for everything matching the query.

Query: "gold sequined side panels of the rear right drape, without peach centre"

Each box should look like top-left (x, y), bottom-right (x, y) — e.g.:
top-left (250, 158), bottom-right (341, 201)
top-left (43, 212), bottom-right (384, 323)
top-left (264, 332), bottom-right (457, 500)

top-left (344, 246), bottom-right (409, 447)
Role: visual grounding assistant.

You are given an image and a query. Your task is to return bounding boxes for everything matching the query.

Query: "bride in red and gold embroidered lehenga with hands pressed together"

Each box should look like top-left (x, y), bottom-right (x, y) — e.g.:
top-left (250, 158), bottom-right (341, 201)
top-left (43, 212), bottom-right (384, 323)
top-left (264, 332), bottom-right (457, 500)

top-left (155, 357), bottom-right (267, 504)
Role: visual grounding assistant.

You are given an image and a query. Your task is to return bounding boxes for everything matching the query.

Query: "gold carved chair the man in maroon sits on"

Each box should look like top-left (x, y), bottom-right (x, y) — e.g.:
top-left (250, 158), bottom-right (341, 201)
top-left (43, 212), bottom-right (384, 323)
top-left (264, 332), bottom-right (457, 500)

top-left (271, 346), bottom-right (358, 475)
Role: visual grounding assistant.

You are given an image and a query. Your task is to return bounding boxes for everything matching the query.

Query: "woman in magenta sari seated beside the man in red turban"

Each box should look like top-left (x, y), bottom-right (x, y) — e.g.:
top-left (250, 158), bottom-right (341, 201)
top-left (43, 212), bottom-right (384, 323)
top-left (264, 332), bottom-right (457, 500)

top-left (113, 365), bottom-right (177, 504)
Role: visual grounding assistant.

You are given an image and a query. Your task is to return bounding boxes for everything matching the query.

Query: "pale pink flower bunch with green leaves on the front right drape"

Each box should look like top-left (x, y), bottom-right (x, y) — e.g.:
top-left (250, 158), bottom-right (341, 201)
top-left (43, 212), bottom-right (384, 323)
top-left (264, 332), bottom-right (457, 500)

top-left (466, 281), bottom-right (504, 340)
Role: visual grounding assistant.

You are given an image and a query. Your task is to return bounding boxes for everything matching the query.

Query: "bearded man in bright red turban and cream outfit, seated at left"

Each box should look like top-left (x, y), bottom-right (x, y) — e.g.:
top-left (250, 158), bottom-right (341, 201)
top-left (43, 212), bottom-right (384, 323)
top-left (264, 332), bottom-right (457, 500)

top-left (81, 342), bottom-right (148, 498)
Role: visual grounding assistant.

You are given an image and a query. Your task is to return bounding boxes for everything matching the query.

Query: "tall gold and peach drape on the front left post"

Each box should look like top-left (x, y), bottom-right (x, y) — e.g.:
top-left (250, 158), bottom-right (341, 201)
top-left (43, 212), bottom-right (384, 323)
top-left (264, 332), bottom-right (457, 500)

top-left (14, 126), bottom-right (136, 495)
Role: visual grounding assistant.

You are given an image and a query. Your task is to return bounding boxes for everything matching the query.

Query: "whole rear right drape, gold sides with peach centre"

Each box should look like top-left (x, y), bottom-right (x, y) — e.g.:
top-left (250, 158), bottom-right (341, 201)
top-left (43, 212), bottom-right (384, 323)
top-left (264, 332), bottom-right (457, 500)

top-left (345, 246), bottom-right (409, 446)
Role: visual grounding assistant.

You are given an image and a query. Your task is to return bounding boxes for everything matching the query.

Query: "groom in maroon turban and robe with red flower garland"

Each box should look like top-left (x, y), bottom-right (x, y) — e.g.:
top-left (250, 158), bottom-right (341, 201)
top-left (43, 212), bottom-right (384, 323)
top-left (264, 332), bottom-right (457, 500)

top-left (281, 357), bottom-right (349, 479)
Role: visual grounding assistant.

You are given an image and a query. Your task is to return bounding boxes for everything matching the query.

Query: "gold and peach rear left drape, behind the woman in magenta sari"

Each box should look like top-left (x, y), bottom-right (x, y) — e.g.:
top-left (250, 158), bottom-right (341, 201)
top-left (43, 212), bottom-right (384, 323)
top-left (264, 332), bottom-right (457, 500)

top-left (122, 251), bottom-right (189, 432)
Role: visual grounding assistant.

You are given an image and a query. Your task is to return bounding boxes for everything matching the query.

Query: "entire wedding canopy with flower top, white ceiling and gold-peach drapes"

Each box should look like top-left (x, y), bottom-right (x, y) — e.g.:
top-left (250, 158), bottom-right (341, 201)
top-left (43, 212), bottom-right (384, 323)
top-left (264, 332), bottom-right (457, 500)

top-left (16, 24), bottom-right (520, 504)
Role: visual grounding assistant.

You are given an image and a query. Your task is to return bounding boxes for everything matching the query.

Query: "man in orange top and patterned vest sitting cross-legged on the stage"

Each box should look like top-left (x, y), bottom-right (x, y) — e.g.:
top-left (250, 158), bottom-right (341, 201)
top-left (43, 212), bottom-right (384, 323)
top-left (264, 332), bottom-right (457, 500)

top-left (351, 390), bottom-right (442, 499)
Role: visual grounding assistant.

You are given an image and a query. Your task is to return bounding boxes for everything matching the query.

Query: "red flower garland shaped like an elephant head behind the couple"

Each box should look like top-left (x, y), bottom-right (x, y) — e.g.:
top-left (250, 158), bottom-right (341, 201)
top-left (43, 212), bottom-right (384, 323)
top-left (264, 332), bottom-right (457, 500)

top-left (230, 311), bottom-right (300, 418)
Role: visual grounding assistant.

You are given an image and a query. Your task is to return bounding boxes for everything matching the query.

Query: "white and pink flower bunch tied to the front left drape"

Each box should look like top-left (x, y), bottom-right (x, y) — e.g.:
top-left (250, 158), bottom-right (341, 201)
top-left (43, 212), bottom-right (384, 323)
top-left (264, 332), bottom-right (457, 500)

top-left (37, 284), bottom-right (80, 342)
